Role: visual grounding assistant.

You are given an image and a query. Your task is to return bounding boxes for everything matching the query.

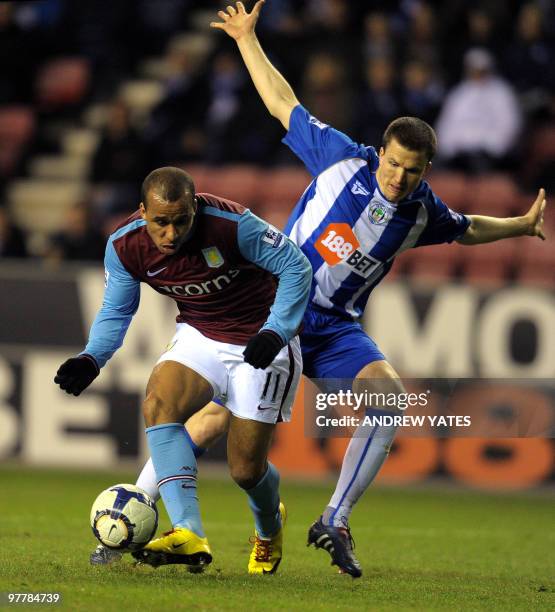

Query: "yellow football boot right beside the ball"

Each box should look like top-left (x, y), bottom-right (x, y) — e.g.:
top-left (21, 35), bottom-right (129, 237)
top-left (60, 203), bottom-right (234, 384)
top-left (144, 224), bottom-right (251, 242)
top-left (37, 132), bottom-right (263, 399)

top-left (133, 527), bottom-right (212, 572)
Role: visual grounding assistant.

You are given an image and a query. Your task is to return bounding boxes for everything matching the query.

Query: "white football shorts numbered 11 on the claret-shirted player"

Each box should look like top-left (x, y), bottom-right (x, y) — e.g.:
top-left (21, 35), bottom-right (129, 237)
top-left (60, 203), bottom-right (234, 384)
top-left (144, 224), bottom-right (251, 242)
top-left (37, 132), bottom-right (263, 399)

top-left (157, 323), bottom-right (302, 423)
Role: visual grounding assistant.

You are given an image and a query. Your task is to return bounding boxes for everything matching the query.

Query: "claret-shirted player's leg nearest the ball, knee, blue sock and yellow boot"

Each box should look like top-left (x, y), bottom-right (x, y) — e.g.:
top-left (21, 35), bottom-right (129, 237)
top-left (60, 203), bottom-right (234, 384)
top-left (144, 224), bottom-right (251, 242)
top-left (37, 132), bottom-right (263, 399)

top-left (133, 361), bottom-right (214, 566)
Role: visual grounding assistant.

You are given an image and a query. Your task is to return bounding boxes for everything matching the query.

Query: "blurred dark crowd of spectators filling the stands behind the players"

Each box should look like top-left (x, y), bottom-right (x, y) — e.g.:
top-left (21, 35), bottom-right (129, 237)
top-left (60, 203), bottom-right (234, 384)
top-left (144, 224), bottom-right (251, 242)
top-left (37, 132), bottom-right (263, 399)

top-left (0, 0), bottom-right (555, 260)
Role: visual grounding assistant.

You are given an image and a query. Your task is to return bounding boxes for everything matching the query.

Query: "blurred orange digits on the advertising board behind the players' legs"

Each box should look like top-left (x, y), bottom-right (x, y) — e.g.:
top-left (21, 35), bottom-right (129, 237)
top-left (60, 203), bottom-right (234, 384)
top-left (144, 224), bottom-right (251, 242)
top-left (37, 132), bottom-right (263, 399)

top-left (270, 381), bottom-right (555, 489)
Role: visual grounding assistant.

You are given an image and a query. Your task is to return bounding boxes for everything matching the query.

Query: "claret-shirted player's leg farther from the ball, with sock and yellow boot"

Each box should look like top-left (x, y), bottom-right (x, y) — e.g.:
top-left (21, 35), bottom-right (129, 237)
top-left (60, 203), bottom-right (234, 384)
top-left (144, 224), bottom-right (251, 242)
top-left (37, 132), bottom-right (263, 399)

top-left (227, 416), bottom-right (285, 574)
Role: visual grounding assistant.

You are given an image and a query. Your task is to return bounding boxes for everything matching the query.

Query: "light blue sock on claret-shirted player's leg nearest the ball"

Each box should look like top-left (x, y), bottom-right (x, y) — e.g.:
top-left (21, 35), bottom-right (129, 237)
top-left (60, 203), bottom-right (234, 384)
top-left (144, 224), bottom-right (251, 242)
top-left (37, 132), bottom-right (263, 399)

top-left (146, 423), bottom-right (204, 537)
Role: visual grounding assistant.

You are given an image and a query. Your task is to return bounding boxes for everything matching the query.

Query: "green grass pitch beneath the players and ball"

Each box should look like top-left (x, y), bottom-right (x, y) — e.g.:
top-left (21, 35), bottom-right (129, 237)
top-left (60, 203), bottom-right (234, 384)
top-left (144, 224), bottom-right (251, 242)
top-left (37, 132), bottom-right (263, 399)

top-left (0, 467), bottom-right (555, 611)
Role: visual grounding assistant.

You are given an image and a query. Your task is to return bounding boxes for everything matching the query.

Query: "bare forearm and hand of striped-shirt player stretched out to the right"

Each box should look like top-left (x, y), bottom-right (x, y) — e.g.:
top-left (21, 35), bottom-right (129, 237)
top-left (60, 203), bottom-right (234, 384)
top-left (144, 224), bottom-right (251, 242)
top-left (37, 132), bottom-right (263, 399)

top-left (457, 189), bottom-right (546, 245)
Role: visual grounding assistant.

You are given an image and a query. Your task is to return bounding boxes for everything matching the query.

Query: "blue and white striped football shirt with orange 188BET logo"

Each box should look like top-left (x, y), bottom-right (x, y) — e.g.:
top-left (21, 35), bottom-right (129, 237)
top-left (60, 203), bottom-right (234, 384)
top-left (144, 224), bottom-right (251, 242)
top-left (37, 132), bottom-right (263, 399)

top-left (283, 105), bottom-right (470, 318)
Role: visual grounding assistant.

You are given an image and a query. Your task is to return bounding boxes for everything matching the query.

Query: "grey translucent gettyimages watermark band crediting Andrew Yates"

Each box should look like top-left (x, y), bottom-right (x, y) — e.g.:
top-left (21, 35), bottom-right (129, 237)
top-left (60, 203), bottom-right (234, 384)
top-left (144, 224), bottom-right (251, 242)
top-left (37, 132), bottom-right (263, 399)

top-left (304, 379), bottom-right (555, 438)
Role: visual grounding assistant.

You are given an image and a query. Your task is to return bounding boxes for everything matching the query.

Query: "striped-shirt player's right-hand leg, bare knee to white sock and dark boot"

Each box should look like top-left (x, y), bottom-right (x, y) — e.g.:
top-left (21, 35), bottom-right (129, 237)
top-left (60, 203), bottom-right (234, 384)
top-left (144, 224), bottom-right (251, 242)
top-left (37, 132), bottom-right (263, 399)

top-left (308, 360), bottom-right (404, 578)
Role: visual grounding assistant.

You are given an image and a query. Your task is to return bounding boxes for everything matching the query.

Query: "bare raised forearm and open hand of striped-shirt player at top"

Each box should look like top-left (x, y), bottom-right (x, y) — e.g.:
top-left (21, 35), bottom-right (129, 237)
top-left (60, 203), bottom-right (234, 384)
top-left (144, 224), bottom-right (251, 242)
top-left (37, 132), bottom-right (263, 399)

top-left (210, 0), bottom-right (299, 130)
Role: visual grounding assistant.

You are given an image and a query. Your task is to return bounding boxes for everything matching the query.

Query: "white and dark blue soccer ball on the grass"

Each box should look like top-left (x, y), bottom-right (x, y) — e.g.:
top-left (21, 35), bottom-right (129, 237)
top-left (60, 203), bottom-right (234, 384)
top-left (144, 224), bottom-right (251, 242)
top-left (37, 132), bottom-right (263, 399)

top-left (91, 484), bottom-right (158, 550)
